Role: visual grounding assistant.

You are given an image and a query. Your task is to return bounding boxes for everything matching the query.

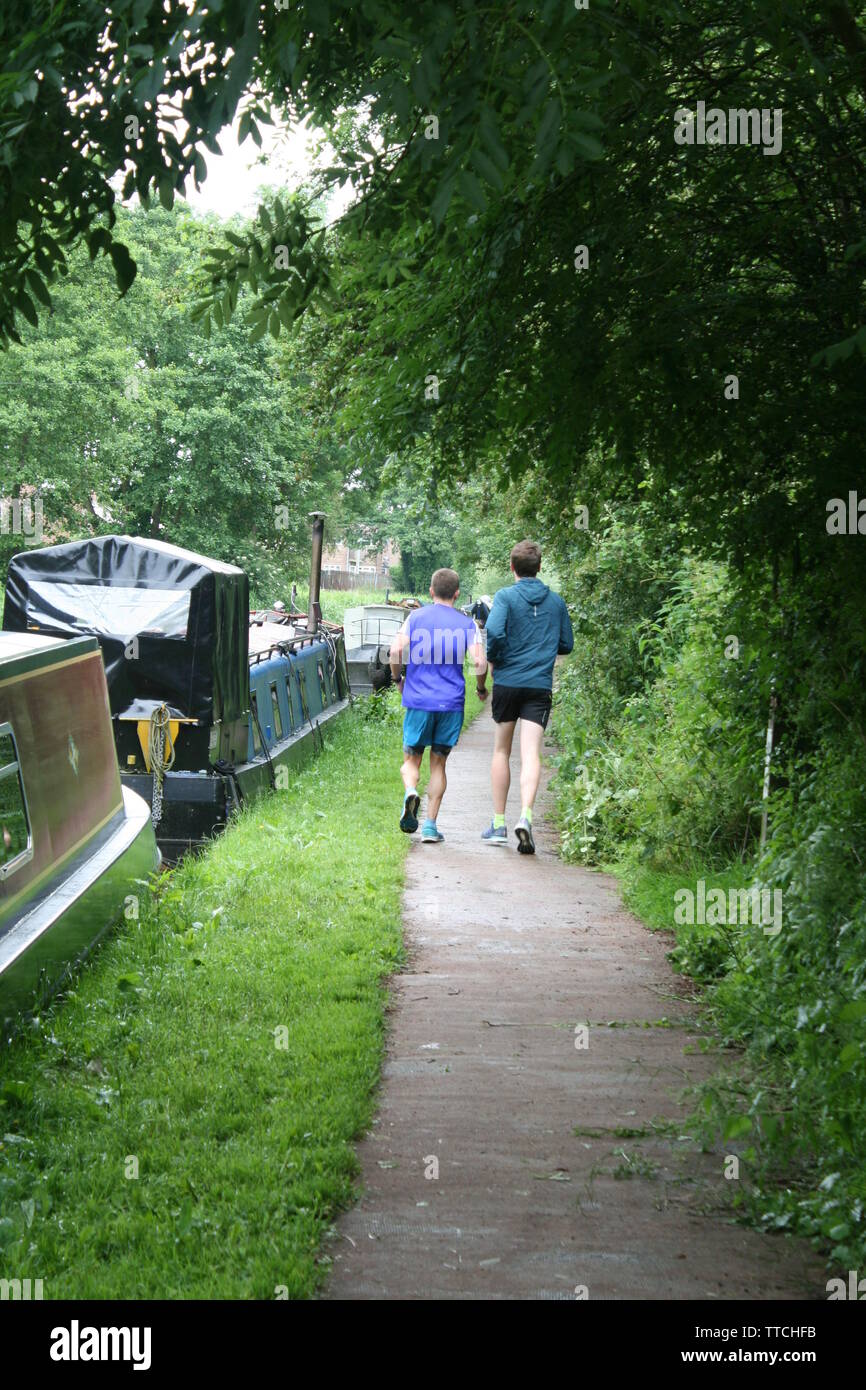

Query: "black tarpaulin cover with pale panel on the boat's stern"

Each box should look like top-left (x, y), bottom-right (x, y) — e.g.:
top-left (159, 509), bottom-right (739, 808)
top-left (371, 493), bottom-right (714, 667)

top-left (3, 535), bottom-right (250, 721)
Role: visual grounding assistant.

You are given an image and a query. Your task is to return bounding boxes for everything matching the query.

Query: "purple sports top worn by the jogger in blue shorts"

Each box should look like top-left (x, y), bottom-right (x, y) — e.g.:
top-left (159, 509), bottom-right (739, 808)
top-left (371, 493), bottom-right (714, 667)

top-left (403, 603), bottom-right (478, 713)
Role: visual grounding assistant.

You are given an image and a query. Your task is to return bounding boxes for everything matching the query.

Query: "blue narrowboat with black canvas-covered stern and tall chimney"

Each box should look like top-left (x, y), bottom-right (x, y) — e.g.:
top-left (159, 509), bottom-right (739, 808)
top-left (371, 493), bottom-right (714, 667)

top-left (3, 513), bottom-right (349, 862)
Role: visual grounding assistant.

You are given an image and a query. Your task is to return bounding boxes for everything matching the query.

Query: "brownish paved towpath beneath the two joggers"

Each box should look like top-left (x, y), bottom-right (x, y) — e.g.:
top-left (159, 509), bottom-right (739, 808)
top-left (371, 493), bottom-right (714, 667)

top-left (327, 710), bottom-right (826, 1300)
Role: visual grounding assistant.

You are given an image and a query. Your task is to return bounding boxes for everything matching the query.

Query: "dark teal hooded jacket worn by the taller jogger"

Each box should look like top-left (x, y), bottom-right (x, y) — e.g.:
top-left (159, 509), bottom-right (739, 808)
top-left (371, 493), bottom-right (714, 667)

top-left (485, 578), bottom-right (574, 689)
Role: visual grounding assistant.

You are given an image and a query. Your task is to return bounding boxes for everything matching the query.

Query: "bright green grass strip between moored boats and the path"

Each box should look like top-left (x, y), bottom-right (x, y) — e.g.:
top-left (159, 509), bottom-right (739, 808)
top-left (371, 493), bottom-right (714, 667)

top-left (0, 682), bottom-right (489, 1298)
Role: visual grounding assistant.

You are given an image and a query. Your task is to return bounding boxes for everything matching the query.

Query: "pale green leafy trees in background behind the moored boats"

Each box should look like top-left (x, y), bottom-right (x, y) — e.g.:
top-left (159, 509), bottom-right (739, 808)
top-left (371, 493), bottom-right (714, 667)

top-left (0, 209), bottom-right (343, 598)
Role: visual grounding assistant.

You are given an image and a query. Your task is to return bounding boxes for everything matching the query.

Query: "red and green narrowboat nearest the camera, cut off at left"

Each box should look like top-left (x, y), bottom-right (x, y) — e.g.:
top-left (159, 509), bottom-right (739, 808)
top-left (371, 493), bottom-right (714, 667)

top-left (0, 632), bottom-right (160, 1037)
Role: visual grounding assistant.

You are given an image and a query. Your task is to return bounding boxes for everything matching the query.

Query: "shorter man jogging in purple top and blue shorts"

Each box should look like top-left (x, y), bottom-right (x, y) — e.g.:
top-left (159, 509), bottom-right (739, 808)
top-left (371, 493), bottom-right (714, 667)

top-left (391, 570), bottom-right (487, 844)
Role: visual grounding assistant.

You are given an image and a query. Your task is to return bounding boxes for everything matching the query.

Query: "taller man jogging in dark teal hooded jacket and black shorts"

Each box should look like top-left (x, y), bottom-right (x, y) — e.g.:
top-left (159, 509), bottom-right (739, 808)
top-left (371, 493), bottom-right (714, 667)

top-left (481, 541), bottom-right (574, 855)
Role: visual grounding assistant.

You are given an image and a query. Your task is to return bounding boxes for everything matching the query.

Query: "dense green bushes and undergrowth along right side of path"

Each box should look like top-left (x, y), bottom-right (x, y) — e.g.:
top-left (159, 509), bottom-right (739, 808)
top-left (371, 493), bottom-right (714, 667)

top-left (556, 510), bottom-right (866, 1268)
